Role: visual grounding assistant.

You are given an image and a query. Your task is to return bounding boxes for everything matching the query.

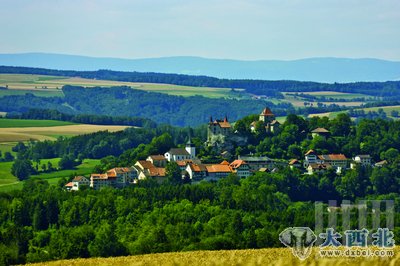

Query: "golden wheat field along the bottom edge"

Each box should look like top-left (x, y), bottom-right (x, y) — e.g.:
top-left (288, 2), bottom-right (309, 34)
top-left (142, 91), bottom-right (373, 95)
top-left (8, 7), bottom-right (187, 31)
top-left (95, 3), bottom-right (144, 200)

top-left (26, 248), bottom-right (400, 266)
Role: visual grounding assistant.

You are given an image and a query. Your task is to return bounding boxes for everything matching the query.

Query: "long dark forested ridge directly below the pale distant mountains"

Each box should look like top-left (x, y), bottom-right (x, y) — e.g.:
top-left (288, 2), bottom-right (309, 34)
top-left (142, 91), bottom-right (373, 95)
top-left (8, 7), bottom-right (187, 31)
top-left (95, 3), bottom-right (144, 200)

top-left (0, 66), bottom-right (400, 100)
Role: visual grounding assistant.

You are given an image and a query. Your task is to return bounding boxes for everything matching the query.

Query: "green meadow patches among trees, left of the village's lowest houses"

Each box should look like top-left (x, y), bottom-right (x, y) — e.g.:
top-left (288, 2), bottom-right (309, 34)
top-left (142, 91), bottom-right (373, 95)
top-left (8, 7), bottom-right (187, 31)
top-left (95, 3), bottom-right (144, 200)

top-left (0, 158), bottom-right (100, 192)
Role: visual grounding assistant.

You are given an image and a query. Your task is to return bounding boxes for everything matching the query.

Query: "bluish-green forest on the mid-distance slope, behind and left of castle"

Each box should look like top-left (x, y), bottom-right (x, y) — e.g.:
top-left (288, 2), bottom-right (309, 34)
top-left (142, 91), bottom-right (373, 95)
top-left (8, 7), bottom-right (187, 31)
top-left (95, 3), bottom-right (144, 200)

top-left (0, 86), bottom-right (294, 126)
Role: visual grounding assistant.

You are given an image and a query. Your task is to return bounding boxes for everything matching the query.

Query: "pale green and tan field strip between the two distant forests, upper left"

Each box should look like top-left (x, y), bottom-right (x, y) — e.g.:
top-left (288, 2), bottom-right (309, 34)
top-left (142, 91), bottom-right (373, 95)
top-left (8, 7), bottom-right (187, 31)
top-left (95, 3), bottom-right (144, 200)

top-left (0, 74), bottom-right (241, 98)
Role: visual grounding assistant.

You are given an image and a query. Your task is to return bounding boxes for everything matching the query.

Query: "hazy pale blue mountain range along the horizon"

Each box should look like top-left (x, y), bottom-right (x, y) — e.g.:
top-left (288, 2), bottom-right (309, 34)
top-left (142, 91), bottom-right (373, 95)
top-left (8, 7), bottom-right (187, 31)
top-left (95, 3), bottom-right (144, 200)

top-left (0, 53), bottom-right (400, 83)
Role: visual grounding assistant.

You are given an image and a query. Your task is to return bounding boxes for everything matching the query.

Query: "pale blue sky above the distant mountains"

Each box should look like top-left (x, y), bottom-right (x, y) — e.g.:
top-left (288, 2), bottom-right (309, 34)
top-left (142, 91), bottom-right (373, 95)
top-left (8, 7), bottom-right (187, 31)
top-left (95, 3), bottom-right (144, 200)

top-left (0, 0), bottom-right (400, 61)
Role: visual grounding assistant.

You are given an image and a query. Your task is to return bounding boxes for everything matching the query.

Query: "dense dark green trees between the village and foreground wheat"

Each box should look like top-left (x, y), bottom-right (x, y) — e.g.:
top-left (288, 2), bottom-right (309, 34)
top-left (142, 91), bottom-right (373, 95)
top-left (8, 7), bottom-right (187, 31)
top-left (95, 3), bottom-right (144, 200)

top-left (0, 169), bottom-right (400, 264)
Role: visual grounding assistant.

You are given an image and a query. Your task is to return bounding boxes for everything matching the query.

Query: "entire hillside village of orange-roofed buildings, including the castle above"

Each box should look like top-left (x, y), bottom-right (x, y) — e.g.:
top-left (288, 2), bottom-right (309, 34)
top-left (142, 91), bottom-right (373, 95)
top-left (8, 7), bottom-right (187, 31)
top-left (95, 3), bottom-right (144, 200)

top-left (65, 107), bottom-right (387, 191)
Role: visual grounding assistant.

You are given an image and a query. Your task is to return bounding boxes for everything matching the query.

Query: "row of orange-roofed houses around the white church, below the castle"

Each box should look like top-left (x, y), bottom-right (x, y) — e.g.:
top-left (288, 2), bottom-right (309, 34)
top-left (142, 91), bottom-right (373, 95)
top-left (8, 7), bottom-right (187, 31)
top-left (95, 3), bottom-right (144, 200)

top-left (65, 141), bottom-right (286, 190)
